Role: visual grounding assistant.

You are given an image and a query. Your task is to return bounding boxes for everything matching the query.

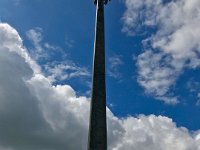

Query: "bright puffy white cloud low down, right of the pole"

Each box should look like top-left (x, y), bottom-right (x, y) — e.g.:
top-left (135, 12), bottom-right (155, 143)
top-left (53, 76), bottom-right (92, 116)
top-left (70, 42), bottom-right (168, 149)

top-left (112, 115), bottom-right (199, 150)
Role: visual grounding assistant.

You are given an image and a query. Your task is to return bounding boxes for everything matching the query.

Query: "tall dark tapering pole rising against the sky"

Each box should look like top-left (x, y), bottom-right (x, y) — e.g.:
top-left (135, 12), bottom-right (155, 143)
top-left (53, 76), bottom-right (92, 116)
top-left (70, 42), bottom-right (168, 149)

top-left (88, 0), bottom-right (108, 150)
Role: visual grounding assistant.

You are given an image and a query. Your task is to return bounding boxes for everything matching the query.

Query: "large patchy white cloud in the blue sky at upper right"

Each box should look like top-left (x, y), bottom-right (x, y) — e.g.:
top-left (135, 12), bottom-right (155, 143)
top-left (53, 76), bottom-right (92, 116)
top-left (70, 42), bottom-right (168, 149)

top-left (123, 0), bottom-right (200, 104)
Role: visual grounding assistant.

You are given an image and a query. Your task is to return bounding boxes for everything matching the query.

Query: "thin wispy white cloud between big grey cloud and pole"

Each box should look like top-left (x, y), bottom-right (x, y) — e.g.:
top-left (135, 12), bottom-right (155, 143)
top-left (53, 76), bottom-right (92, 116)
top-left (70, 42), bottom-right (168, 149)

top-left (26, 28), bottom-right (90, 82)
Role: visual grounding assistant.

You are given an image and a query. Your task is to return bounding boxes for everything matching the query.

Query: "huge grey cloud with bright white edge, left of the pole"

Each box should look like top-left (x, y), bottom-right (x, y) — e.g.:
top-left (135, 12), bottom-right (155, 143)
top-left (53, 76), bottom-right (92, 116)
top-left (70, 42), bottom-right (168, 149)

top-left (0, 24), bottom-right (89, 150)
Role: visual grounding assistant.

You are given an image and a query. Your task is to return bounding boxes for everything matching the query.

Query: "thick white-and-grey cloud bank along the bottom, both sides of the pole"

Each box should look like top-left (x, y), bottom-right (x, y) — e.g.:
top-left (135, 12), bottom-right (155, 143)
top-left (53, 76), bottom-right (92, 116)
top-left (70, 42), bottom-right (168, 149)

top-left (0, 23), bottom-right (200, 150)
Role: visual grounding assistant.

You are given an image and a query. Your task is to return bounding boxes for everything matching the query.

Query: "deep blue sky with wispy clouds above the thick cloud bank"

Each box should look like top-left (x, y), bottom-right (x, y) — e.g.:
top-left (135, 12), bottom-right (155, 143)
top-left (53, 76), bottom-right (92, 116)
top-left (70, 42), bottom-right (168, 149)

top-left (0, 0), bottom-right (200, 150)
